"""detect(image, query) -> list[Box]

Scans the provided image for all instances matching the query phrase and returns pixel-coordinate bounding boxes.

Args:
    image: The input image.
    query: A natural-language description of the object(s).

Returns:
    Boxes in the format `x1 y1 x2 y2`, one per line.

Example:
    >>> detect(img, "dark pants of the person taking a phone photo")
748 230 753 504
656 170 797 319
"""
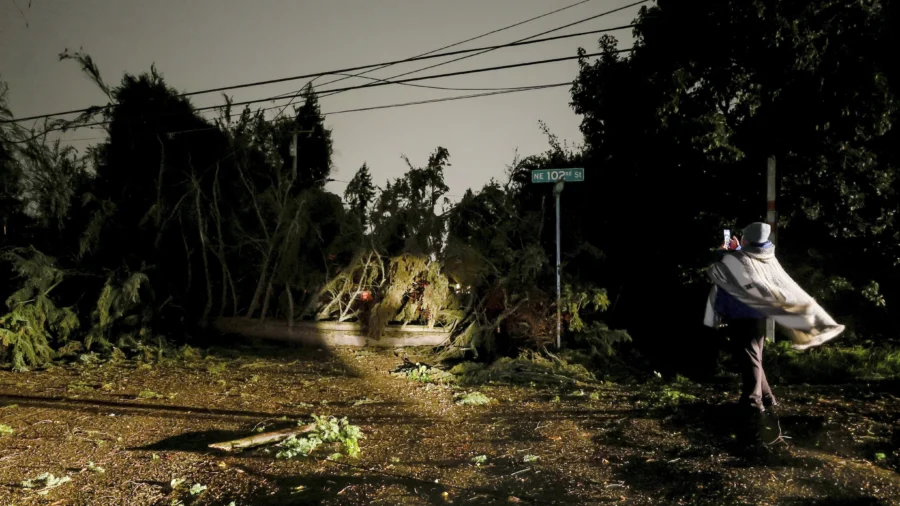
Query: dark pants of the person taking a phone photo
728 319 775 411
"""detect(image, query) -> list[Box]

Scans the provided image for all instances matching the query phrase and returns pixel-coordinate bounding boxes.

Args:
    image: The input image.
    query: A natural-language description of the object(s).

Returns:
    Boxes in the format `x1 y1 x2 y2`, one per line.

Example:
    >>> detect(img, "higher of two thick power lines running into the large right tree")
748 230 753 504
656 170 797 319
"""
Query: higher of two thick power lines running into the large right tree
0 23 632 123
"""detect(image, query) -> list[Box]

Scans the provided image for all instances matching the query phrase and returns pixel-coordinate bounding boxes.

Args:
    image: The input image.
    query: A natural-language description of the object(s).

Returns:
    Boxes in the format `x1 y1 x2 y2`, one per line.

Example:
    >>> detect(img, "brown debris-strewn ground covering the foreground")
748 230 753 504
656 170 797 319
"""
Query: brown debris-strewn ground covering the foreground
0 347 900 506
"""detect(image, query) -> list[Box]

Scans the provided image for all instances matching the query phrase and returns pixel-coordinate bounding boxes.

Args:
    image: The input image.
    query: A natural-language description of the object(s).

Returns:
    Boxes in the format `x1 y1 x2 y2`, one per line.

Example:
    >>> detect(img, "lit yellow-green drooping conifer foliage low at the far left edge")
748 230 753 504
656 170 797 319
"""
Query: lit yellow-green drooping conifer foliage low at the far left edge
0 248 79 370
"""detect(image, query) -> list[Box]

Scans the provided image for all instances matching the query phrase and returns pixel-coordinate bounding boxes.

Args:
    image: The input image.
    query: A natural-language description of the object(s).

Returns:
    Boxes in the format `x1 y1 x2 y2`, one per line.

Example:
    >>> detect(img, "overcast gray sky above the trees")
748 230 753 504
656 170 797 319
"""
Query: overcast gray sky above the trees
0 0 638 195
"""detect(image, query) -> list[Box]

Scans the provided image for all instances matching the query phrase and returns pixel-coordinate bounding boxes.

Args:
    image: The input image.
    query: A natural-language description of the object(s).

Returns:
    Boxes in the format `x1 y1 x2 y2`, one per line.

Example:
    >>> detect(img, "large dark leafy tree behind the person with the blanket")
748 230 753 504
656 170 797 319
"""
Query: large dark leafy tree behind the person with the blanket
568 0 900 356
